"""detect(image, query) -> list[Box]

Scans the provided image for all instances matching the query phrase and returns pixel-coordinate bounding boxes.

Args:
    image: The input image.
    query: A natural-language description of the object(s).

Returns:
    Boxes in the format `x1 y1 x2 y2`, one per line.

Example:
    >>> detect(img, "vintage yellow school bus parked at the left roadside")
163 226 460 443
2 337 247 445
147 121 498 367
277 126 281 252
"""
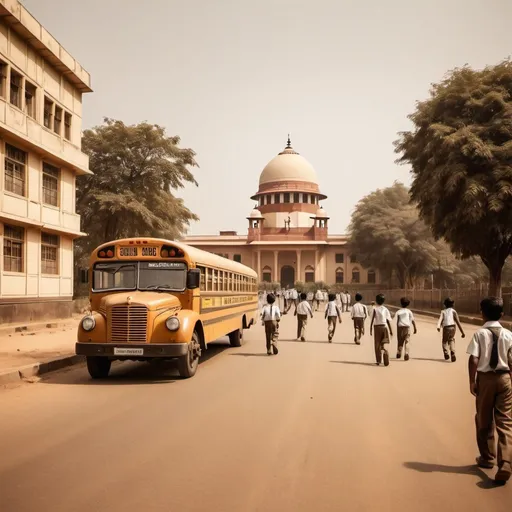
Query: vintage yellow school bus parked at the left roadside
76 238 258 379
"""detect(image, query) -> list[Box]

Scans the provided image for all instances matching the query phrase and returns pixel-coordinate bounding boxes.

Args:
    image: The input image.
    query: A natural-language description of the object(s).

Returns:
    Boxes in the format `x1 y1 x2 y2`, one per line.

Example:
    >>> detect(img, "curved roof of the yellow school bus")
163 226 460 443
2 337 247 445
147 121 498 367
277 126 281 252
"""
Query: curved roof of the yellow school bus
92 236 258 278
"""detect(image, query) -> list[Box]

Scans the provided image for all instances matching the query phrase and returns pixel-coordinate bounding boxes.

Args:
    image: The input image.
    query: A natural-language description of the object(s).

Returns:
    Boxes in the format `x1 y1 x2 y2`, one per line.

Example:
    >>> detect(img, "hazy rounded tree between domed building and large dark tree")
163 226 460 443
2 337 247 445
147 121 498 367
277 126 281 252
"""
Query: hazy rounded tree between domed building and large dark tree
349 183 449 288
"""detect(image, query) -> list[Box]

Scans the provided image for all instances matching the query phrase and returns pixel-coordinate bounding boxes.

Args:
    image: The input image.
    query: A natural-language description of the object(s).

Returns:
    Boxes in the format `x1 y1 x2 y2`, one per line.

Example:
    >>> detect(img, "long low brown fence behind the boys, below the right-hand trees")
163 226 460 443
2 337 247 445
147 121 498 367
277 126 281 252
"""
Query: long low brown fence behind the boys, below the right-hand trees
362 288 512 316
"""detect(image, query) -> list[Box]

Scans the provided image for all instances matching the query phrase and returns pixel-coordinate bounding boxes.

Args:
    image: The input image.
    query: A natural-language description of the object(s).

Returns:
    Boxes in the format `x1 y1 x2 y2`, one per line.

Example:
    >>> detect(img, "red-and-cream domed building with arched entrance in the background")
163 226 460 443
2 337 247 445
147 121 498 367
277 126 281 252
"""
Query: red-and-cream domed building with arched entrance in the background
184 138 379 288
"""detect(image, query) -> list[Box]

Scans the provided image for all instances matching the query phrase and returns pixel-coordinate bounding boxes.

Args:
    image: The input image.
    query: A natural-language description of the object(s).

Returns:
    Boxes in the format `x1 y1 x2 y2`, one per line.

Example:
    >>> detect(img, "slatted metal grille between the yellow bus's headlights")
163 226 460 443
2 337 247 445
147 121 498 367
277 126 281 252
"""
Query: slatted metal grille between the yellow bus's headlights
108 306 148 343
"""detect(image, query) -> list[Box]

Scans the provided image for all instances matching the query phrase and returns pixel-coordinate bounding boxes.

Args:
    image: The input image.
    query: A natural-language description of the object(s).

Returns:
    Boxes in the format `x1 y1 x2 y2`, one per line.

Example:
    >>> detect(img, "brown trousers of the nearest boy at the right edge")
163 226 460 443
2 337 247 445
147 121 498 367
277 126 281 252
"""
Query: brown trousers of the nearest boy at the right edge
475 372 512 468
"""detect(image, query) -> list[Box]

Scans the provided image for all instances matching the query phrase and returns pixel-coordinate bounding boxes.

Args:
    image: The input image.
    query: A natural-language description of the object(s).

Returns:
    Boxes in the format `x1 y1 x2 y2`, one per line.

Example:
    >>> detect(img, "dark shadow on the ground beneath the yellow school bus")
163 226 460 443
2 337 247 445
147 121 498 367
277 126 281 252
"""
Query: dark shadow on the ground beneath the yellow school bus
40 341 230 386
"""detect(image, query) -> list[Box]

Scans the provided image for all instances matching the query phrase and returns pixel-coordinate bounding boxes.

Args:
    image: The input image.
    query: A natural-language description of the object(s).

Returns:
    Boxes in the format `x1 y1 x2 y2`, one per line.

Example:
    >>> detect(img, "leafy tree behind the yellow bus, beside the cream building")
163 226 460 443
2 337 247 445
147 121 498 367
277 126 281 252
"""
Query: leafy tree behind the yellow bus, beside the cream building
77 118 197 262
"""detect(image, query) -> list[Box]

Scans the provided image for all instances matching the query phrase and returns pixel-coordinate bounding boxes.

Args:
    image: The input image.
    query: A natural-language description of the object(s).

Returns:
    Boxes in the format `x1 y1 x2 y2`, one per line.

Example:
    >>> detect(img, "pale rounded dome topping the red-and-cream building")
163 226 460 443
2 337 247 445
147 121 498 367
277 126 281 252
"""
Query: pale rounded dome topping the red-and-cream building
260 144 318 186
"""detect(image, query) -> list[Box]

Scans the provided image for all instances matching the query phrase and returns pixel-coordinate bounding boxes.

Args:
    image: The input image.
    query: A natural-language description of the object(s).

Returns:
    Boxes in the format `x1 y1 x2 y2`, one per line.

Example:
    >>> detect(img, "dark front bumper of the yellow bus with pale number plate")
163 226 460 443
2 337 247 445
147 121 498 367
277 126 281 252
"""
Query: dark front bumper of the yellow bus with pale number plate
75 342 188 359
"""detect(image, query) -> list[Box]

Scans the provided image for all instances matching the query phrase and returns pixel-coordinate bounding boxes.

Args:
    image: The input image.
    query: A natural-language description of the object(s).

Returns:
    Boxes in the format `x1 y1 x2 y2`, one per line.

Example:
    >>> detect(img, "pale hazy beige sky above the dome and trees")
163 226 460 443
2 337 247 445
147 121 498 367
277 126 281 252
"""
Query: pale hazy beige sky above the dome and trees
23 0 512 234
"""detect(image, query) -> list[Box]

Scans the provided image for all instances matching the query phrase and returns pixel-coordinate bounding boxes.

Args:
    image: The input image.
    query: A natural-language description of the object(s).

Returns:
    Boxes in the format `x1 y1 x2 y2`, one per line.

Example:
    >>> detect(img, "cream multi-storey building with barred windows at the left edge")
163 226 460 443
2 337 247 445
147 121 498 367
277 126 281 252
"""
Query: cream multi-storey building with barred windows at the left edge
0 0 91 322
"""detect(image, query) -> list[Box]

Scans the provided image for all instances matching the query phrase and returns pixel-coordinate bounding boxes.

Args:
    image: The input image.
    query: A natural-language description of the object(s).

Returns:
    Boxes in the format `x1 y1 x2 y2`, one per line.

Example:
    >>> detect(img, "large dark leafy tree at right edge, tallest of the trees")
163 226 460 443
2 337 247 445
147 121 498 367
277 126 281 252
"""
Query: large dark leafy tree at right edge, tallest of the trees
395 60 512 295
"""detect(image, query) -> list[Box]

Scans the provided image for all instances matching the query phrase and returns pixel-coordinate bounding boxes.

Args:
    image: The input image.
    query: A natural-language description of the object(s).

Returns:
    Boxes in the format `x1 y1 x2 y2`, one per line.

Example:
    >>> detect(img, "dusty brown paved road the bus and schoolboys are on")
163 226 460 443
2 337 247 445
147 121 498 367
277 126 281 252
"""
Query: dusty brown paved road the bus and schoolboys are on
0 315 512 512
